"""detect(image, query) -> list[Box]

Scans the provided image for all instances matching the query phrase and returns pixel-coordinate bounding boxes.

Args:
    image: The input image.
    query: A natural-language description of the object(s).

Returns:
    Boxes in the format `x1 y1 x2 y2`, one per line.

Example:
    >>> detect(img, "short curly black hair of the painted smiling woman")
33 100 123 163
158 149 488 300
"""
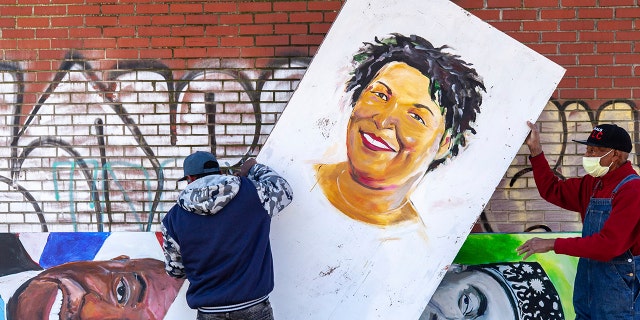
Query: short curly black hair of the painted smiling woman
346 33 486 170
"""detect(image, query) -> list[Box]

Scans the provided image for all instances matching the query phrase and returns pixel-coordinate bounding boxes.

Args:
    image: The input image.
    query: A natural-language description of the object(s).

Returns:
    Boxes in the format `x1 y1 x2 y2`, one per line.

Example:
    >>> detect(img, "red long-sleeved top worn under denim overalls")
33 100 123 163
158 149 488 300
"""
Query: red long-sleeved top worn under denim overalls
530 154 640 261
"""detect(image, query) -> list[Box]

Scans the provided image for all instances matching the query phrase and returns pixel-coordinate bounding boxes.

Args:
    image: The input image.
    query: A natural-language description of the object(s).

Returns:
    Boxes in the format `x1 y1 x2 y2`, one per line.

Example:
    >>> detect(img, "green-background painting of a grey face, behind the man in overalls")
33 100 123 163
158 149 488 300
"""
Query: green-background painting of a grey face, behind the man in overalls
420 233 580 320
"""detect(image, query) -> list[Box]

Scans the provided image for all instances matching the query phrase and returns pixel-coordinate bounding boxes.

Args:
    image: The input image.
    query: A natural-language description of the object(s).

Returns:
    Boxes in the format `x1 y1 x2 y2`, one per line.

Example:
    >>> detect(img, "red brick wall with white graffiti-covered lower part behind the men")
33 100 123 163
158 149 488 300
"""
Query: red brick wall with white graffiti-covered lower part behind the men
0 0 640 232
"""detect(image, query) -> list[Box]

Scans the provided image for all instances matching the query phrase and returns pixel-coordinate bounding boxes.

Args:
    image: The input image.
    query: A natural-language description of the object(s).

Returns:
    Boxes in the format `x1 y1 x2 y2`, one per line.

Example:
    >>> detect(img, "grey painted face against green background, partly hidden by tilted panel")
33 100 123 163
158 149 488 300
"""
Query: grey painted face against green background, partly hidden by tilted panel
421 271 518 320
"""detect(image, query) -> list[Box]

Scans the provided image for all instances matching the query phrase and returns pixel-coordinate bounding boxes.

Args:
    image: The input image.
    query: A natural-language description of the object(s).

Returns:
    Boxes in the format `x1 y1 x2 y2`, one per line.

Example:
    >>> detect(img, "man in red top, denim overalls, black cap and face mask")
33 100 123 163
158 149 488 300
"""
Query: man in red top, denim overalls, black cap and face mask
517 122 640 320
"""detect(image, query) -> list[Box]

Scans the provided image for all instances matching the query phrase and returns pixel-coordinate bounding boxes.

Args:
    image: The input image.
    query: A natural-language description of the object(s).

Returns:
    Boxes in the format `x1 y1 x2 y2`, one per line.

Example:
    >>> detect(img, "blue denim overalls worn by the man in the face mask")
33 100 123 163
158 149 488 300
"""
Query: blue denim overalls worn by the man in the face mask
573 174 640 320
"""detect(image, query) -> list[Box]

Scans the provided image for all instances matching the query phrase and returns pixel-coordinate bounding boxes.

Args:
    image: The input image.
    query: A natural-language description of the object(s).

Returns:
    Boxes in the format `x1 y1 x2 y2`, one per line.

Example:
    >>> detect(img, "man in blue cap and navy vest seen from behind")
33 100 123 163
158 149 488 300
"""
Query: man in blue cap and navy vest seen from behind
162 151 293 320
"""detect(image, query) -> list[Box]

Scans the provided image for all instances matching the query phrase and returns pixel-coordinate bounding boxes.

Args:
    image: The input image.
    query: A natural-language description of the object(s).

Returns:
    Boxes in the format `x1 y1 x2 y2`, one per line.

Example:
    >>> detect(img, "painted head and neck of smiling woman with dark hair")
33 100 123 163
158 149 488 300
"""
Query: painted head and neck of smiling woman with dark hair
316 34 486 226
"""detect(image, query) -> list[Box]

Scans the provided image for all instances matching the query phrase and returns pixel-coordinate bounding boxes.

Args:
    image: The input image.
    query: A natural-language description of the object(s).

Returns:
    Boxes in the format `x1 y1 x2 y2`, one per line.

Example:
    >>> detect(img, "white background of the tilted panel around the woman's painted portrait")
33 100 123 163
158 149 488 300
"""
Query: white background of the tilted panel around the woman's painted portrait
258 0 564 319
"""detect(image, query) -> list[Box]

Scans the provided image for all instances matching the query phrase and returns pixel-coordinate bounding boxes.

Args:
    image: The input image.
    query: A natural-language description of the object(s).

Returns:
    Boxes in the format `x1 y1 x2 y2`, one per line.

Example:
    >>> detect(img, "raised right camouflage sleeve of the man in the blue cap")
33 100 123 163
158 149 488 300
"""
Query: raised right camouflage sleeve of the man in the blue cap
247 163 293 216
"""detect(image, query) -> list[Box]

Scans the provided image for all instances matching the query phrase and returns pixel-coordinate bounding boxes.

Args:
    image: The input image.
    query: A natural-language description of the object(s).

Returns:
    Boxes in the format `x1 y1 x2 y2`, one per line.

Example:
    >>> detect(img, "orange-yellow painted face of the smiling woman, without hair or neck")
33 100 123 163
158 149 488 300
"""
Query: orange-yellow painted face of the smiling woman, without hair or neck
347 62 445 189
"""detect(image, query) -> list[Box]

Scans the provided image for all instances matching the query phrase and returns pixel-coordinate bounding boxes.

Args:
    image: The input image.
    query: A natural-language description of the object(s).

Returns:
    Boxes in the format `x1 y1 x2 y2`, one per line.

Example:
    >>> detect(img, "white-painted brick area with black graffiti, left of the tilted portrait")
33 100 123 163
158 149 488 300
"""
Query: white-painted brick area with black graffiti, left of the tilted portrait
0 51 308 231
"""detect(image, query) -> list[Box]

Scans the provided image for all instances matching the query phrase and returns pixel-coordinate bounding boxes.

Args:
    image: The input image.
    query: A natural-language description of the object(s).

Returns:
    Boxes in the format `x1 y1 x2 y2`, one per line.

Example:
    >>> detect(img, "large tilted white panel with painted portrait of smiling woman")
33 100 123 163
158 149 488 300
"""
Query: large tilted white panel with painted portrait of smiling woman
258 0 564 319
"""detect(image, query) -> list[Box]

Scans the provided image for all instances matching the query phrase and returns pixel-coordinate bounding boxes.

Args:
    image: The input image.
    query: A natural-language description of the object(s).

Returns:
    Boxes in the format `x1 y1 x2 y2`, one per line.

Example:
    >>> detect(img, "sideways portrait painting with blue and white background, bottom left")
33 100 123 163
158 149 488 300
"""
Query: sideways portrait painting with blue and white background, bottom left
0 233 195 320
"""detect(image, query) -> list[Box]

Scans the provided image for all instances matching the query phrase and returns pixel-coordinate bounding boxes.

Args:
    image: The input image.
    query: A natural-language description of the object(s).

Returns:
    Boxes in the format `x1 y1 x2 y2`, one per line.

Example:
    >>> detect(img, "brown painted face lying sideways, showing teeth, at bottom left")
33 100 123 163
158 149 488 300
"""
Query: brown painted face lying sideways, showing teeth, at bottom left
9 256 183 320
